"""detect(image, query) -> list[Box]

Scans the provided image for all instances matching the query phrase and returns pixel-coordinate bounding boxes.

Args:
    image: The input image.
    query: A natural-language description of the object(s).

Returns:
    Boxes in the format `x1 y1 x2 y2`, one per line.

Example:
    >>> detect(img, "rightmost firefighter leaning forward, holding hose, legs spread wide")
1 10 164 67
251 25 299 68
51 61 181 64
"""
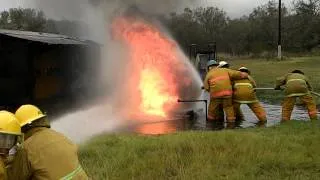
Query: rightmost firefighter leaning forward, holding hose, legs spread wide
275 70 318 121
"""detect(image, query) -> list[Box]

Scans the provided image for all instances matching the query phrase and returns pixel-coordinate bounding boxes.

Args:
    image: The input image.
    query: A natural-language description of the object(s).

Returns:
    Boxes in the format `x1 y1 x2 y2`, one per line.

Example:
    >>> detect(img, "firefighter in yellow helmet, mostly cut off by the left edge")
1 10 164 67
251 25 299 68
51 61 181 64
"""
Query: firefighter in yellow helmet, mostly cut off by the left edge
0 111 21 180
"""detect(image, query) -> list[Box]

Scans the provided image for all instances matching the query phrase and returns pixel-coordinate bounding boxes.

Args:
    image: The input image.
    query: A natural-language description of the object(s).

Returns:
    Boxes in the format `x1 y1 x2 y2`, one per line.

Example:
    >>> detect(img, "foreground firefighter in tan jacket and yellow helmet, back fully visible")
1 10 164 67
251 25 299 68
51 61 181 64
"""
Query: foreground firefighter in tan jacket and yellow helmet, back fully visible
8 105 88 180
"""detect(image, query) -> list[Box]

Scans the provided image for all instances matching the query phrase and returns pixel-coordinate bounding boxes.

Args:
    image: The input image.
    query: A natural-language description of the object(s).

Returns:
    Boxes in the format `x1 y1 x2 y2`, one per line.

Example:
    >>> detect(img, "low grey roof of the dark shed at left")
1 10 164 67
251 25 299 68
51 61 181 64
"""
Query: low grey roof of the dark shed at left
0 29 90 45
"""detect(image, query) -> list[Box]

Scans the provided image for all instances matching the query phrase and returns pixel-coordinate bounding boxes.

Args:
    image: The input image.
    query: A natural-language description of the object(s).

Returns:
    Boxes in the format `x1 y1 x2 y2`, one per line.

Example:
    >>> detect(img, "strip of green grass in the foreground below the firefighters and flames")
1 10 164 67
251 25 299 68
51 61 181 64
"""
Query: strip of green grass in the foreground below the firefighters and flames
80 121 320 180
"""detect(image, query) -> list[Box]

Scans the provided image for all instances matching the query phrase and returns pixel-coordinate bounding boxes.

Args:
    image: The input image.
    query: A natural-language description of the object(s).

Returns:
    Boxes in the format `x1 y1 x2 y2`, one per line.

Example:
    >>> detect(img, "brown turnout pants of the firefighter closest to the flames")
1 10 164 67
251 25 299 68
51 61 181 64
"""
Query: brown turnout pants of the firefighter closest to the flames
208 97 236 122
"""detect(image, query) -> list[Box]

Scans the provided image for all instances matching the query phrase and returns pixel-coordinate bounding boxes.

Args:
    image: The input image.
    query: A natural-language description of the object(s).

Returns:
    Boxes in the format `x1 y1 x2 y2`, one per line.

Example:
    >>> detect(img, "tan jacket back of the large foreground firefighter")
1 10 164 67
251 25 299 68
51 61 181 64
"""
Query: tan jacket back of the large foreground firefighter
24 128 88 180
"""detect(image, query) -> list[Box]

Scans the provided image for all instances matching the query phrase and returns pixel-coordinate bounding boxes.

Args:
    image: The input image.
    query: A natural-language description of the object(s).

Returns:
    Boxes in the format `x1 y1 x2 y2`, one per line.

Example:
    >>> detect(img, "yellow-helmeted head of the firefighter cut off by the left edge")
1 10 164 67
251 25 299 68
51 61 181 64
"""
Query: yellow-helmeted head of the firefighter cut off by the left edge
0 111 22 154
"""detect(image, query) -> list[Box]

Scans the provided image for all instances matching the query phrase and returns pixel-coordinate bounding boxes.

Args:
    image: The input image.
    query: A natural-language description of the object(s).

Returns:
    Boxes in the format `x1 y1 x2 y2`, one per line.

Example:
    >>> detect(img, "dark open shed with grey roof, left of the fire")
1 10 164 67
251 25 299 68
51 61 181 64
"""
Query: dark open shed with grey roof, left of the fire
0 29 100 114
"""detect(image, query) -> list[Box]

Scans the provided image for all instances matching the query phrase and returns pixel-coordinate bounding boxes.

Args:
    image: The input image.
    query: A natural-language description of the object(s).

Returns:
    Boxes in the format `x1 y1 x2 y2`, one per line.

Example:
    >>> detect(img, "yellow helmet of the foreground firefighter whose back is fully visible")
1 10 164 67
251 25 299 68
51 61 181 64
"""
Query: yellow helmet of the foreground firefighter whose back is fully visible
15 104 46 127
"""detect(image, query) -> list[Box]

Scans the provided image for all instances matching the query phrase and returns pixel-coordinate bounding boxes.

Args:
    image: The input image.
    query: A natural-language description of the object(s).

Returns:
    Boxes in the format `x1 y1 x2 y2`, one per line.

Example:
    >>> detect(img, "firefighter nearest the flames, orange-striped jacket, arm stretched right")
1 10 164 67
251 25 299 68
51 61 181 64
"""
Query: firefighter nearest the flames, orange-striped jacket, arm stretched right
204 60 248 123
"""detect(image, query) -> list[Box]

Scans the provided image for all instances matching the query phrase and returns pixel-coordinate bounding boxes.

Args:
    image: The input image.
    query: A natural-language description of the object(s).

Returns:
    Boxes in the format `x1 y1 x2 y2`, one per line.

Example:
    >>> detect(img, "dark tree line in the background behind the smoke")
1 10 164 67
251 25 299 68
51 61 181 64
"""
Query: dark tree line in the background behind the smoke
0 0 320 56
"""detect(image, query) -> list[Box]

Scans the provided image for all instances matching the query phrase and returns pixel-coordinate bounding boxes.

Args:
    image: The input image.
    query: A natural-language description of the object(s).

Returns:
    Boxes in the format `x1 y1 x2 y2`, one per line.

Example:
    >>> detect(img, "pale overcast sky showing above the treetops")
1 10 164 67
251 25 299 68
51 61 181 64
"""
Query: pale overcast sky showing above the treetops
0 0 293 19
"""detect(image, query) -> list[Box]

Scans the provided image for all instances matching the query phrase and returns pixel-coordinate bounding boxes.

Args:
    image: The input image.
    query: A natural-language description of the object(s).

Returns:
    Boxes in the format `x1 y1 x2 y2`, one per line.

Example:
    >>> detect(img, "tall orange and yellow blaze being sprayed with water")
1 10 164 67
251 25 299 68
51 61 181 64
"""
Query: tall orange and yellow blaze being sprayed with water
112 17 198 119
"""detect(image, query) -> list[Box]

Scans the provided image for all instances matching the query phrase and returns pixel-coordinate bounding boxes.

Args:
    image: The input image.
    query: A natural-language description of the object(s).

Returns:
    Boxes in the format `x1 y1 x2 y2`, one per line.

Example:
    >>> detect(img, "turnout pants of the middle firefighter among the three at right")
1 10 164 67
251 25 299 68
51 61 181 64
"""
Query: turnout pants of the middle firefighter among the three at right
233 102 267 122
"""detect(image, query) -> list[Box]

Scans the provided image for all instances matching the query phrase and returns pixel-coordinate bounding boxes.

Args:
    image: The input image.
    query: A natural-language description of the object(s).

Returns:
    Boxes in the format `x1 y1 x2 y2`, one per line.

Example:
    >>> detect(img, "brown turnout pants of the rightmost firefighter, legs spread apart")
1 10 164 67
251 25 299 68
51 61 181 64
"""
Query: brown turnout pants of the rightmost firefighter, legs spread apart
282 95 318 121
